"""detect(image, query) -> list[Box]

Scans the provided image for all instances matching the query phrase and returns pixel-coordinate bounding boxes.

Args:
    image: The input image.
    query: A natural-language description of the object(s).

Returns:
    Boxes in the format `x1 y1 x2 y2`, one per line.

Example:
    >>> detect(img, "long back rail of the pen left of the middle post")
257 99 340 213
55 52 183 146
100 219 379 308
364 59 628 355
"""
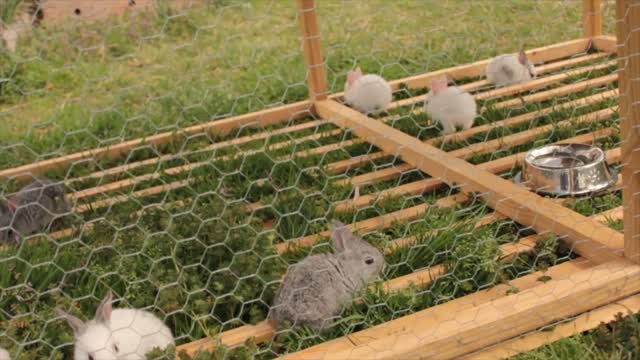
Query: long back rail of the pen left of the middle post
0 101 312 179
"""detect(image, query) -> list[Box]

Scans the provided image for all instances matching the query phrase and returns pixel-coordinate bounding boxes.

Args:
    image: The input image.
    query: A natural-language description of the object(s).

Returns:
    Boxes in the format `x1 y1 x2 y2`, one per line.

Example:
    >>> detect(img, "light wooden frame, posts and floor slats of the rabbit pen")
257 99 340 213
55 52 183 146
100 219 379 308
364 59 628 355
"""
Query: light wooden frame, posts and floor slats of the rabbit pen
0 0 640 359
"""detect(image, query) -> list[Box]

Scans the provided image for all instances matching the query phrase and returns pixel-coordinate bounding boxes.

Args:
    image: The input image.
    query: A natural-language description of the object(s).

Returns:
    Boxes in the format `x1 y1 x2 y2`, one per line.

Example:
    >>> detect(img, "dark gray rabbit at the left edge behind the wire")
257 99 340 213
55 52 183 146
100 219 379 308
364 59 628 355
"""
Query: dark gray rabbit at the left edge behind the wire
0 178 71 244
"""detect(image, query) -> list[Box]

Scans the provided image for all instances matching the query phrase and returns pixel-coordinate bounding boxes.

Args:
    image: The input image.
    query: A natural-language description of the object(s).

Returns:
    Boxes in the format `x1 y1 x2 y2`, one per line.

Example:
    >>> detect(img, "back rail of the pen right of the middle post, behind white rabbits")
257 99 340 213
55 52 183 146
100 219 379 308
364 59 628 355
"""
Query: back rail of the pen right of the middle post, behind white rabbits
382 39 590 90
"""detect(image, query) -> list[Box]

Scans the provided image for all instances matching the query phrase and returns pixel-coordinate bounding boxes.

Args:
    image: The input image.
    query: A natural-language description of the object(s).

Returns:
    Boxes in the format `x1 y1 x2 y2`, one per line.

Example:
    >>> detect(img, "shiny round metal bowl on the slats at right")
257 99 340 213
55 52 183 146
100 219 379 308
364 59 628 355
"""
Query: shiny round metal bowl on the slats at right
516 144 617 196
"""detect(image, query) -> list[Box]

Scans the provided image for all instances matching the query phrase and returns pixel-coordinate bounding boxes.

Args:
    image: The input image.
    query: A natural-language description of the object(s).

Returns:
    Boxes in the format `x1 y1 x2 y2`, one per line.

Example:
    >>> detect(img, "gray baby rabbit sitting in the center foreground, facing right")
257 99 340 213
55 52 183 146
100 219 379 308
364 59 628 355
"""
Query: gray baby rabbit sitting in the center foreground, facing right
269 221 384 331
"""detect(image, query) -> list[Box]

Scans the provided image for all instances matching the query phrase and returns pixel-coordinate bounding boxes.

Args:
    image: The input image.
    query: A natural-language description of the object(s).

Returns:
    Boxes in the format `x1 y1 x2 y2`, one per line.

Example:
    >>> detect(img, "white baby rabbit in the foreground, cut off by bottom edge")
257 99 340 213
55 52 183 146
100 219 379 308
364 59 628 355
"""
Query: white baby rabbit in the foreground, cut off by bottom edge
55 291 175 360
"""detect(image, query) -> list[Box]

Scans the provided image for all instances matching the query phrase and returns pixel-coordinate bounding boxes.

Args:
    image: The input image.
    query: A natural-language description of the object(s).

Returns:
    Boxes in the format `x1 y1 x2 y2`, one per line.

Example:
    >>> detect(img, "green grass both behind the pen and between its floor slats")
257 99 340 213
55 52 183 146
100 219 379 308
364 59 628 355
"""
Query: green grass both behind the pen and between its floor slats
0 0 637 359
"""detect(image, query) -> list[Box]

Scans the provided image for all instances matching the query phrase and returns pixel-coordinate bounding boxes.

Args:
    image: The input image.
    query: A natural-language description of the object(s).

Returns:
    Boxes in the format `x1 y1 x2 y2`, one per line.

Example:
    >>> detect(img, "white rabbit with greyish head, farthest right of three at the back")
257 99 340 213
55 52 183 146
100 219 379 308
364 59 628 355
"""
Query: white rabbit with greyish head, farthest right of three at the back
486 50 536 86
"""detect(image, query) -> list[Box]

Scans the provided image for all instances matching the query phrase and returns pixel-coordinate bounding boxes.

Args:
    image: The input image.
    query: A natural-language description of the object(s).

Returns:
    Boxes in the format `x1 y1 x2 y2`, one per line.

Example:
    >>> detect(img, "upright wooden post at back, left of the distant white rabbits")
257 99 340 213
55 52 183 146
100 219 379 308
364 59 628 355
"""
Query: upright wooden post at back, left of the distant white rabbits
297 0 328 101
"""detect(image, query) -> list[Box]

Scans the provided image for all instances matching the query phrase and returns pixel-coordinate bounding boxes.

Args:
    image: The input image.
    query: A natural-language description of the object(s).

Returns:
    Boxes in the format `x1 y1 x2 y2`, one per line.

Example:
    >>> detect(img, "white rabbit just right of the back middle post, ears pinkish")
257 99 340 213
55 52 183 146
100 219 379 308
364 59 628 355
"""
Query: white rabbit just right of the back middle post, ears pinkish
344 68 391 115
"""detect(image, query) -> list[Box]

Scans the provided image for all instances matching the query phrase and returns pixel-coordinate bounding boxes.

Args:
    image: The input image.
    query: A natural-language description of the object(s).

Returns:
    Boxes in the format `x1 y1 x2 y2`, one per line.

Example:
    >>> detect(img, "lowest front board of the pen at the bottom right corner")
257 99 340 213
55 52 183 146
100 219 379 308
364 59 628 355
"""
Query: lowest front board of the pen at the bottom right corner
460 295 640 360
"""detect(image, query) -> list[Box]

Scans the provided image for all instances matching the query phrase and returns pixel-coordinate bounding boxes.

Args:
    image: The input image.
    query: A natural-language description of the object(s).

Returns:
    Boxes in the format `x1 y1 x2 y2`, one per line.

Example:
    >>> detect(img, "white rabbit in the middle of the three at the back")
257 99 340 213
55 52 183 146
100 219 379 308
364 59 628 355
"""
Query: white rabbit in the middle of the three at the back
425 77 477 135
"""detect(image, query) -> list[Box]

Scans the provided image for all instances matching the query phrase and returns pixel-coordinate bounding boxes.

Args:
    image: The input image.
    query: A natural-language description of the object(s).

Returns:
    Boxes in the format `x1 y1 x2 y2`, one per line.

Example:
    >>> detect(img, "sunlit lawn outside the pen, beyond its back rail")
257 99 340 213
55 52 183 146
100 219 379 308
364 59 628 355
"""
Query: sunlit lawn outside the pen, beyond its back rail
0 0 596 167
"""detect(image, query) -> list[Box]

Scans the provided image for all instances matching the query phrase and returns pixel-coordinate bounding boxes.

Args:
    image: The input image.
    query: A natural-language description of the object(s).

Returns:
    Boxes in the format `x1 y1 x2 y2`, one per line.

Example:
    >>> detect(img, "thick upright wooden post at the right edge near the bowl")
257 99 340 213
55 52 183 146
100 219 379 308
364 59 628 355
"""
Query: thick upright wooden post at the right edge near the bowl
616 0 640 263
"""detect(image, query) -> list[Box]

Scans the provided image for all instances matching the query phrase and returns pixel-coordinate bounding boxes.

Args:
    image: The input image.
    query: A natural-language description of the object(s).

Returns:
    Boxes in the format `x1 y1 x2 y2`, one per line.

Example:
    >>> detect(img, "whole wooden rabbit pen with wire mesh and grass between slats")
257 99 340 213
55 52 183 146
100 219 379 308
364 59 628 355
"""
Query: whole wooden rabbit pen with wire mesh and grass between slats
0 0 640 359
